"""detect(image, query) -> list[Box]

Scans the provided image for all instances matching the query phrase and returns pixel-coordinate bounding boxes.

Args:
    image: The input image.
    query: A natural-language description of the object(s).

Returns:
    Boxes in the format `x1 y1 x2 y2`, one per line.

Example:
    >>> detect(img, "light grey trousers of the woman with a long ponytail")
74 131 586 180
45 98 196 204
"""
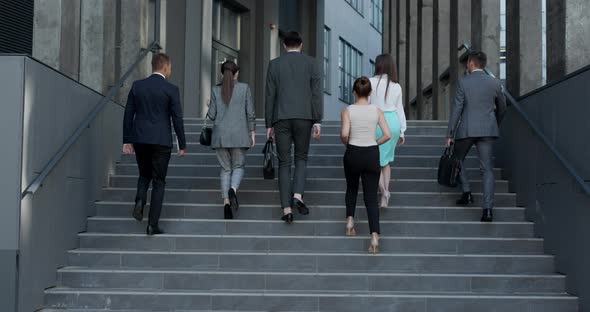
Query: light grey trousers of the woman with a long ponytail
215 148 247 199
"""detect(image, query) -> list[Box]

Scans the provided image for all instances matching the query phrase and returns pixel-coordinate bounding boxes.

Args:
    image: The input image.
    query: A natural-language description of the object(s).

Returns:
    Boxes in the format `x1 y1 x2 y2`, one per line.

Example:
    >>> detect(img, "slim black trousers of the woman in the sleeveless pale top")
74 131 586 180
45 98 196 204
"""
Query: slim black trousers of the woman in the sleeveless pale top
344 145 381 233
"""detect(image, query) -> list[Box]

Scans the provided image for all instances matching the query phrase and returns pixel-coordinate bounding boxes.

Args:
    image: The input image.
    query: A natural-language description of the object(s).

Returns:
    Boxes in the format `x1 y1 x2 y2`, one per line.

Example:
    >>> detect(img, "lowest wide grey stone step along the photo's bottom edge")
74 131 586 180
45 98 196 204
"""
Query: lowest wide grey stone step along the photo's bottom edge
46 288 578 312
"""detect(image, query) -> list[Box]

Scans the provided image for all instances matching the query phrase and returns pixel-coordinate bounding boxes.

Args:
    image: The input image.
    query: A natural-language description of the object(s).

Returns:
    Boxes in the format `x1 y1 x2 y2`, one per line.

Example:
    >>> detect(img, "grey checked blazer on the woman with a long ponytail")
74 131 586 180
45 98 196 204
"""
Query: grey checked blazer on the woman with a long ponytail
207 82 256 149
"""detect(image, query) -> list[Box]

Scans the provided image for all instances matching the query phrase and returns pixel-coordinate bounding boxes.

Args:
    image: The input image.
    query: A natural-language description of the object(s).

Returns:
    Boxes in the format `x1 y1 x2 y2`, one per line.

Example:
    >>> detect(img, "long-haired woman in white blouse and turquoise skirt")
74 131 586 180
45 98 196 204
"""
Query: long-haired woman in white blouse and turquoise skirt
369 54 406 208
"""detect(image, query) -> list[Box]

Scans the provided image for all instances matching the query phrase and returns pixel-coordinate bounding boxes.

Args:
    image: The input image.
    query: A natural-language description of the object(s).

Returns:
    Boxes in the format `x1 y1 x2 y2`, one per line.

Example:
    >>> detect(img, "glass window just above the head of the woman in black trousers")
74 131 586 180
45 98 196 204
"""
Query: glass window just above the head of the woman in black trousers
338 38 363 104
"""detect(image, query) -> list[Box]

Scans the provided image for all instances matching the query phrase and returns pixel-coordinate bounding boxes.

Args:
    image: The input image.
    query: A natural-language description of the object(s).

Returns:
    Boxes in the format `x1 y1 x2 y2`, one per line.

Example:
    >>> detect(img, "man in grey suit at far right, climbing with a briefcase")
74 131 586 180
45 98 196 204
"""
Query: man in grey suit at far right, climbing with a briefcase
446 52 506 222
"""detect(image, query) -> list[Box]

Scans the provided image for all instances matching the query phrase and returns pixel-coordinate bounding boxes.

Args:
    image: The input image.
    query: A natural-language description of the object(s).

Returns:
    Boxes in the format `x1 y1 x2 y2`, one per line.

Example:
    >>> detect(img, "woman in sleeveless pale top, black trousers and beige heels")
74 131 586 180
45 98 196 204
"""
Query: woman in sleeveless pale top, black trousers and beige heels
340 77 391 254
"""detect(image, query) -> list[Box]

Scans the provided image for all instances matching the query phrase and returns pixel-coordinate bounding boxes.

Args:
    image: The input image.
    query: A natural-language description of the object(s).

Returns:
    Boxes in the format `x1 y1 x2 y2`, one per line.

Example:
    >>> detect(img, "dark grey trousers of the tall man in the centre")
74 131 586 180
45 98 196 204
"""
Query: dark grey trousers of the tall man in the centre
273 119 313 208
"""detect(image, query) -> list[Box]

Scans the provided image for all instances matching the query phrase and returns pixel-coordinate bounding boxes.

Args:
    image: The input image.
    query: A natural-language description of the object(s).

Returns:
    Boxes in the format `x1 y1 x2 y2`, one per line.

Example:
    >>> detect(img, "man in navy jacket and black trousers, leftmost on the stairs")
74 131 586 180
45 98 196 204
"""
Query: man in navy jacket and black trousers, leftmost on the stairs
123 53 186 235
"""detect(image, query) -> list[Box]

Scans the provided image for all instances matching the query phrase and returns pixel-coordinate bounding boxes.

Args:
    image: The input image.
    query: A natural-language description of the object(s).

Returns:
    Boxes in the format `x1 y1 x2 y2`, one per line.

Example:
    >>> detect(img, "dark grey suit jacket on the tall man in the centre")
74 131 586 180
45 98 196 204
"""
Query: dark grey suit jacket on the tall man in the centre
265 52 324 128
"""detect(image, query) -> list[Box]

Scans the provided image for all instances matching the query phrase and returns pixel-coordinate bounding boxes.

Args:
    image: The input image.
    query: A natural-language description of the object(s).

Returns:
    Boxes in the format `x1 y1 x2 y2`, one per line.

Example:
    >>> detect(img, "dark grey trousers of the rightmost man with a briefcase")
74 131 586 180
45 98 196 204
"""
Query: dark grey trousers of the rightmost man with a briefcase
455 137 496 209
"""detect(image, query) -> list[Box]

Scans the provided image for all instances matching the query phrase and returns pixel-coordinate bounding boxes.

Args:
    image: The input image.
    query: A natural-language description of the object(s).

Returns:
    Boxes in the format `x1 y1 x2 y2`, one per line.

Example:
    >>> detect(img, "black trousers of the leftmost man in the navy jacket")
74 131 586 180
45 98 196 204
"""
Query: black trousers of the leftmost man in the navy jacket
133 144 172 226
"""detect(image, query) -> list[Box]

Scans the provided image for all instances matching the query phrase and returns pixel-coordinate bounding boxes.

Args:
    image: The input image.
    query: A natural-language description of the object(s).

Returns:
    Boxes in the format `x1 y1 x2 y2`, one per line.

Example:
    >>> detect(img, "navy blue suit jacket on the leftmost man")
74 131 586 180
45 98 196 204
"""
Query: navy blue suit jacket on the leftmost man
123 74 186 149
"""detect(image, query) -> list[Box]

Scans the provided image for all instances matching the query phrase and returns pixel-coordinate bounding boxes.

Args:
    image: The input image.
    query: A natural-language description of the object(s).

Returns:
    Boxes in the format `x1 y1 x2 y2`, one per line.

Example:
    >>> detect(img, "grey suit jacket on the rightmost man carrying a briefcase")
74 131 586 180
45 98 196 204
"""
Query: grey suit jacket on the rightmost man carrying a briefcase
447 71 506 140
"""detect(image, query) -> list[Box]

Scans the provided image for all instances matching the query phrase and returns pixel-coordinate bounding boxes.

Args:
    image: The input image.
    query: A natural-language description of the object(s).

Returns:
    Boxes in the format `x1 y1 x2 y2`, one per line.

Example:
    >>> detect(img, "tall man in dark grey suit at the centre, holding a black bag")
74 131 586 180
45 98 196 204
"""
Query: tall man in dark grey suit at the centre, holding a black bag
265 31 324 223
